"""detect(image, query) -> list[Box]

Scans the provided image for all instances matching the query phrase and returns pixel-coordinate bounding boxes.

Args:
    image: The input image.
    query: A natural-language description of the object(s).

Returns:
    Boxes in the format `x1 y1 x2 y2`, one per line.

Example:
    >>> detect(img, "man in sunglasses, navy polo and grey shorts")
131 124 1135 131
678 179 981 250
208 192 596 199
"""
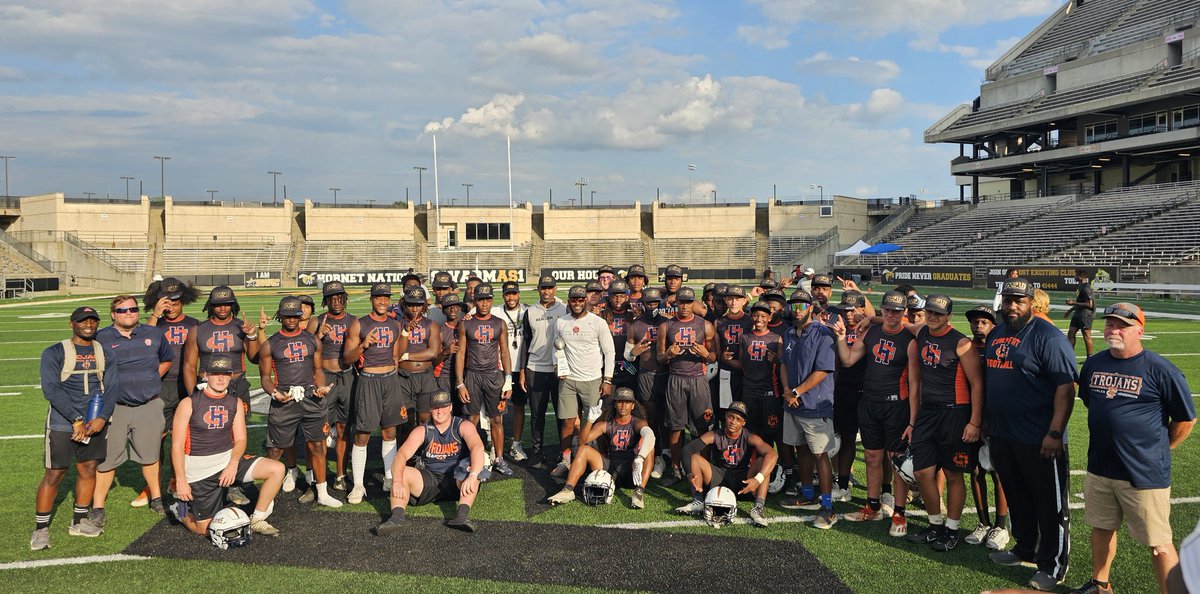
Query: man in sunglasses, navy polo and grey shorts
89 295 175 524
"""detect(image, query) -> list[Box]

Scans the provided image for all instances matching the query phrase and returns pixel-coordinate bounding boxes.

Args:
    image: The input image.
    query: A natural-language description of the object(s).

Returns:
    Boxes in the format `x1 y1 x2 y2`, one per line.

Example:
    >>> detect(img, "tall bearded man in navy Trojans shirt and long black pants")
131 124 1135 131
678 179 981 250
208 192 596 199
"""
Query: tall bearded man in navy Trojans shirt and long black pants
984 277 1076 590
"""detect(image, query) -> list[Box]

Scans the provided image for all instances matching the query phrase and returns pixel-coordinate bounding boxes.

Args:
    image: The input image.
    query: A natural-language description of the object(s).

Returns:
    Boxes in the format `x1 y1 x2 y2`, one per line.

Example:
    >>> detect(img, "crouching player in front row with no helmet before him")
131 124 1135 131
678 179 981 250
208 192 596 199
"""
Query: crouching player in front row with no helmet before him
376 391 486 536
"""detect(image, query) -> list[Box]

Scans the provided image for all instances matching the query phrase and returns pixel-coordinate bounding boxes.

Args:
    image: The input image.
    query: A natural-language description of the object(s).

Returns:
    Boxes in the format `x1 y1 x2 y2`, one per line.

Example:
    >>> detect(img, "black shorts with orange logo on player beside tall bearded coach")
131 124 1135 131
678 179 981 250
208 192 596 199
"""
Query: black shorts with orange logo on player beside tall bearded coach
910 406 979 473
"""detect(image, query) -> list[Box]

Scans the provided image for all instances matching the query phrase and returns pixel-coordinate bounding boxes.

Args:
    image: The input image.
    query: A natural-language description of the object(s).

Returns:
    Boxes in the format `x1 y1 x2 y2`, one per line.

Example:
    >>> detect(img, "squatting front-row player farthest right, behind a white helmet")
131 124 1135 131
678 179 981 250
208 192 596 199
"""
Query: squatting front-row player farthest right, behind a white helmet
676 402 779 528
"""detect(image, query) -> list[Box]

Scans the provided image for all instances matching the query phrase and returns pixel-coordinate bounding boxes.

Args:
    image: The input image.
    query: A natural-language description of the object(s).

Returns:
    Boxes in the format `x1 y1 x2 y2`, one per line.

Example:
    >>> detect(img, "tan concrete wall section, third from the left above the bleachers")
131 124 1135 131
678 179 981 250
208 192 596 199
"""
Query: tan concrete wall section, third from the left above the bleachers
304 200 415 241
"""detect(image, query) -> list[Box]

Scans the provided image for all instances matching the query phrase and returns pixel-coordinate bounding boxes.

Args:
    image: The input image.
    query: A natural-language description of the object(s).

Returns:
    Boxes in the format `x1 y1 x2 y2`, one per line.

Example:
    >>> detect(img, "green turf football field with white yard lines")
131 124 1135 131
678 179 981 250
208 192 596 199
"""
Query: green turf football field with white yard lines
0 285 1200 593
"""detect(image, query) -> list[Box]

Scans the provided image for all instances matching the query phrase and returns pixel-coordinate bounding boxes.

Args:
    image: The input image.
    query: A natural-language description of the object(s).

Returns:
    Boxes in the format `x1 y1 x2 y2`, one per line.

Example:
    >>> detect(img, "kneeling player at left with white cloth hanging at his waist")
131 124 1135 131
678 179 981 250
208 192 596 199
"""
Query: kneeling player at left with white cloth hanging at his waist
170 354 283 536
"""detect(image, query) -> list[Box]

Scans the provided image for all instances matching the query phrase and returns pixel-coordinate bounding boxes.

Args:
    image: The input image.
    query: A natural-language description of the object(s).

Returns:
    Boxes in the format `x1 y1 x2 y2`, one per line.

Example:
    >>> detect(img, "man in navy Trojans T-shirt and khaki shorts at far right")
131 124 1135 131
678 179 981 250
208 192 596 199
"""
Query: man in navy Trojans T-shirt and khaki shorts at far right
1073 304 1196 593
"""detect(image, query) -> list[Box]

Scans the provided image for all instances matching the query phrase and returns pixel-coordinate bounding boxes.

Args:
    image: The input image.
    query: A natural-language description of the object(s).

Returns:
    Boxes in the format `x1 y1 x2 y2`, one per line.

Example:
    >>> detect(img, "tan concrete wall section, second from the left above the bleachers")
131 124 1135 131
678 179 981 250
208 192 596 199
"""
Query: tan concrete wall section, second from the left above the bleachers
164 196 293 244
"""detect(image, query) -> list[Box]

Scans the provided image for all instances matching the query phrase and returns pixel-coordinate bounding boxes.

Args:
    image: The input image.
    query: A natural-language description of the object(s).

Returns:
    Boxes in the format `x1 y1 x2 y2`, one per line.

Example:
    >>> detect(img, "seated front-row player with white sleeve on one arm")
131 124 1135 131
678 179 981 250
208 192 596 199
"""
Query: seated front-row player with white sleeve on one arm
547 388 654 509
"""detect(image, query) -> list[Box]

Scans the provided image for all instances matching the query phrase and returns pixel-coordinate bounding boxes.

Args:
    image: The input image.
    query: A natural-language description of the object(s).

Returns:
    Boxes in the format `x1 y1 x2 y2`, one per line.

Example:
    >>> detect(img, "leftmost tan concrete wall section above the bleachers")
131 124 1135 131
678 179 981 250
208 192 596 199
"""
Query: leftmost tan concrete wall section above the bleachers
8 193 150 245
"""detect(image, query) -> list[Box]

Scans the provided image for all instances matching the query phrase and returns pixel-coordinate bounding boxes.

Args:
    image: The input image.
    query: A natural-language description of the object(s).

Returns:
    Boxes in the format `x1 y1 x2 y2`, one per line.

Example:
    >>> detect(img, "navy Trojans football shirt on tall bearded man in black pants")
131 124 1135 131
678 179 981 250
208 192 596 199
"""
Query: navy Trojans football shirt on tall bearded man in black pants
984 317 1076 445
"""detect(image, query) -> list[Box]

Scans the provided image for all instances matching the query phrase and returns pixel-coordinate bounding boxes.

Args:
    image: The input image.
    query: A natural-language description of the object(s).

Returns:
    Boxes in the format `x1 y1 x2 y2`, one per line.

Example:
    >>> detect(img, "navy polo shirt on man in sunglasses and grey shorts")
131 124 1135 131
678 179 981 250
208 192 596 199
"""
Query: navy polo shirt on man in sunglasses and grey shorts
96 324 175 406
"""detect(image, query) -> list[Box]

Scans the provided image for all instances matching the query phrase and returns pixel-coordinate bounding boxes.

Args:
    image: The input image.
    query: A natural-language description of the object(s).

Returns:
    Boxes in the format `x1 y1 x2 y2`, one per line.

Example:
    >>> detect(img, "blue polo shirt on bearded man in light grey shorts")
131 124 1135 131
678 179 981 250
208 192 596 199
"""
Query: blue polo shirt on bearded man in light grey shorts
784 323 838 418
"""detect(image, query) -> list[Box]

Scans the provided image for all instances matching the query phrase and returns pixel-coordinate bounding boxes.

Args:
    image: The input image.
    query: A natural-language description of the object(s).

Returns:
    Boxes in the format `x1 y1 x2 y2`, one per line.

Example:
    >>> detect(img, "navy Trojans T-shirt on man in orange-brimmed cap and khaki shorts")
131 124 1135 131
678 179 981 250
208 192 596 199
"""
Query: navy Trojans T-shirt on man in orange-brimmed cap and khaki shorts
1079 350 1196 488
